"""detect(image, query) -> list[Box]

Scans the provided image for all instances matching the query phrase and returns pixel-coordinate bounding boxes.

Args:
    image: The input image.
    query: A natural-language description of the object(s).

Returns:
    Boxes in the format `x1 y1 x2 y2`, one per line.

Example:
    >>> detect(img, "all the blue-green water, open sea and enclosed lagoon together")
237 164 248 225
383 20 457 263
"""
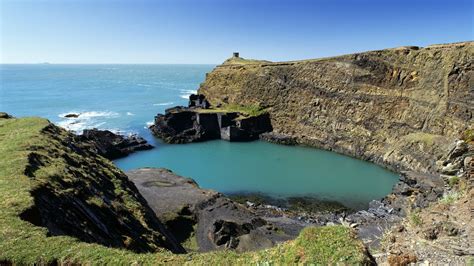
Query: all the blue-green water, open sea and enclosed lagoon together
0 64 398 209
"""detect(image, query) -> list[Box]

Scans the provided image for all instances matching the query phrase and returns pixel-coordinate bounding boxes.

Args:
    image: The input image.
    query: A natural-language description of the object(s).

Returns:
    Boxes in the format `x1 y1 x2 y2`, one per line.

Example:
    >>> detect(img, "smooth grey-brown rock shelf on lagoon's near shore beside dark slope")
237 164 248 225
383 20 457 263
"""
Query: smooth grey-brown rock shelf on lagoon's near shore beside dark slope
127 168 303 251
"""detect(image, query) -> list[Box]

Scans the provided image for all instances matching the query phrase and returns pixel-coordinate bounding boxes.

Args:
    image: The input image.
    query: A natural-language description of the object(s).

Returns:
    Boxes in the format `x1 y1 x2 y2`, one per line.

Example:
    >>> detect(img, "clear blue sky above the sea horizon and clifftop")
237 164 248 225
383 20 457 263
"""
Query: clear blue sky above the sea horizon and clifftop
0 0 474 64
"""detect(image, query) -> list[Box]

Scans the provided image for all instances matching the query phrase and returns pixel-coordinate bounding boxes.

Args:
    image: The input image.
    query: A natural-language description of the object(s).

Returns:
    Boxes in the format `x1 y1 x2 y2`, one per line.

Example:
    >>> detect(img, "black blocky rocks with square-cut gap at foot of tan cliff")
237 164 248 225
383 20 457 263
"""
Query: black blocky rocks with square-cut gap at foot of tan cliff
150 95 272 143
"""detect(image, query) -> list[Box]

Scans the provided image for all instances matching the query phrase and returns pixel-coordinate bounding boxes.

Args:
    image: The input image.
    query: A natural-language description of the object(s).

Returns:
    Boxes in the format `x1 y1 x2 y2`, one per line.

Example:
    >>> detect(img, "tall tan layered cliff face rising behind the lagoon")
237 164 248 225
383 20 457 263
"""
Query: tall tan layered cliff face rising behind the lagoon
199 42 474 172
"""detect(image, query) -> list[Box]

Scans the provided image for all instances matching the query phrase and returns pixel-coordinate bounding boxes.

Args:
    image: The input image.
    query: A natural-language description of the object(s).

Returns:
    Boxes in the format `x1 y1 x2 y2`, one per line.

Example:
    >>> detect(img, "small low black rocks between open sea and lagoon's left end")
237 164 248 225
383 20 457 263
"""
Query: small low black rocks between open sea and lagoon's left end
79 129 153 160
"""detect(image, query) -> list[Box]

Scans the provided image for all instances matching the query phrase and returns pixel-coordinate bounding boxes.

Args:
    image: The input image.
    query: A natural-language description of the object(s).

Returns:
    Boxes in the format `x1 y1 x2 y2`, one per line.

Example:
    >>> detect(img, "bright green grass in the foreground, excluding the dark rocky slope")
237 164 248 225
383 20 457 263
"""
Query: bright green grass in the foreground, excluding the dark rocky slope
0 118 366 264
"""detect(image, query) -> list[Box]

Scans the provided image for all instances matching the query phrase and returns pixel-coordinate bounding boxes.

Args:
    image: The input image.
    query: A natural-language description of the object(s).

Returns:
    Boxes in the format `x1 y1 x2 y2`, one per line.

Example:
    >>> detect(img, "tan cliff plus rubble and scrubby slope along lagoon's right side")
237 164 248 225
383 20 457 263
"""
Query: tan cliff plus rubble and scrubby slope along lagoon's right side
194 42 474 265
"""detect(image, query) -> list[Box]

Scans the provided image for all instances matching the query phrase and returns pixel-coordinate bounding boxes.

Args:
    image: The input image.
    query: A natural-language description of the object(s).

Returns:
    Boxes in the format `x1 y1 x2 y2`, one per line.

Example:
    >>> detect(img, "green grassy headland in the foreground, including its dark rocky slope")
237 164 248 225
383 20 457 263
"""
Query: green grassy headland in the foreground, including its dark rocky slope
0 116 368 264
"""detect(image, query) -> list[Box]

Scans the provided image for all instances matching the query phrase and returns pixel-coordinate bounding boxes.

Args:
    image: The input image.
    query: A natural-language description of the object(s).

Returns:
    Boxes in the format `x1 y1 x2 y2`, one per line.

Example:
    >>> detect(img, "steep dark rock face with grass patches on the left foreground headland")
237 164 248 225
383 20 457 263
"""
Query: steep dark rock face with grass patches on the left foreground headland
17 119 184 253
